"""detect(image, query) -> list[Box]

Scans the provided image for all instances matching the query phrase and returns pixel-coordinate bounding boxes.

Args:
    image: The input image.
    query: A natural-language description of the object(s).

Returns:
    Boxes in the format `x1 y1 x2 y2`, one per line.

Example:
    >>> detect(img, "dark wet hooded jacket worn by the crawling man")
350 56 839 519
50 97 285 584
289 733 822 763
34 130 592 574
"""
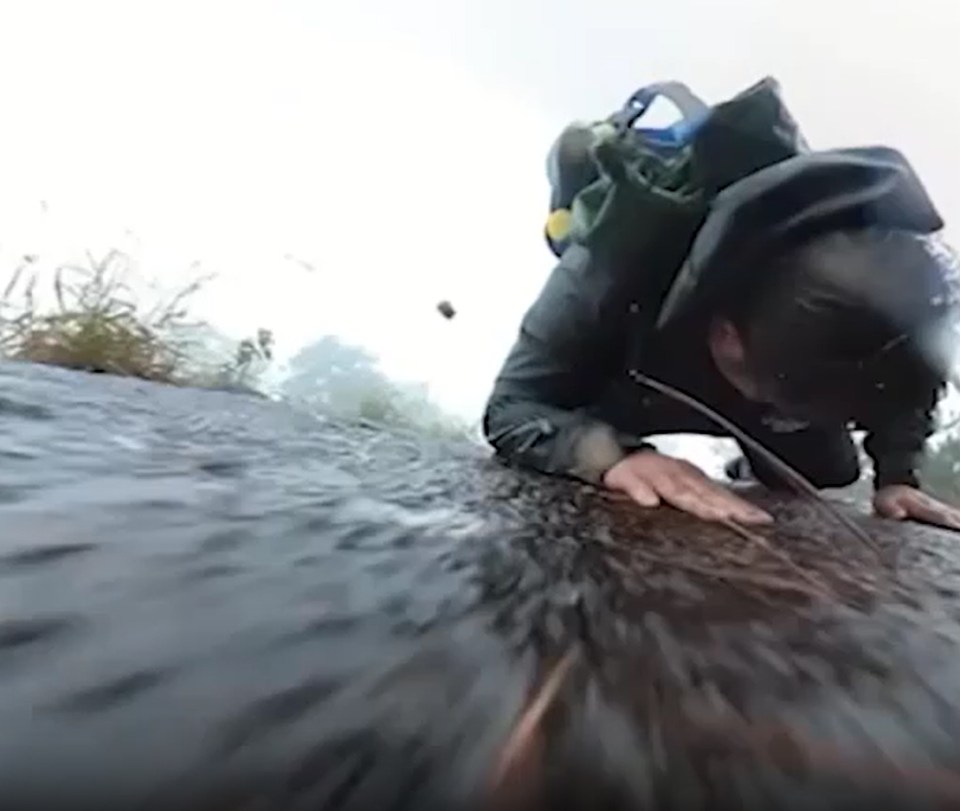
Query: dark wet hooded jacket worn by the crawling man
483 149 943 487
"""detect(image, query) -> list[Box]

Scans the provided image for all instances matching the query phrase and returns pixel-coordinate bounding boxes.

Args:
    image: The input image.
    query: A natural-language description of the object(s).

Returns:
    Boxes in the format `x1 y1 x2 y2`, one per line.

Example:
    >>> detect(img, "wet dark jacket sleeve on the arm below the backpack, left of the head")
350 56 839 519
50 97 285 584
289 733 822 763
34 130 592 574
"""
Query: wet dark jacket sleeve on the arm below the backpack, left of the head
483 246 649 483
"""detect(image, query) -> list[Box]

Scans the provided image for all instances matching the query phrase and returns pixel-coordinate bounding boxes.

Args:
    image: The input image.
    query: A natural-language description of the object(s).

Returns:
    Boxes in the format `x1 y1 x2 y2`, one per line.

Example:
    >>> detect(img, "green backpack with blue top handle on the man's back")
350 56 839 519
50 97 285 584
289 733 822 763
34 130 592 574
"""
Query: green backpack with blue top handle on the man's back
545 77 807 320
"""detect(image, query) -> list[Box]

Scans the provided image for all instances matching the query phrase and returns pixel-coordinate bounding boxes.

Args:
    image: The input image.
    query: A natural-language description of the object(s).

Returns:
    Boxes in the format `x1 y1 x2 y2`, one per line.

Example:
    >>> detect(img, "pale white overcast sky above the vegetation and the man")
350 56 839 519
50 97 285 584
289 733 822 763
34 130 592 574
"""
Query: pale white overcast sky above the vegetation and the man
0 0 960 432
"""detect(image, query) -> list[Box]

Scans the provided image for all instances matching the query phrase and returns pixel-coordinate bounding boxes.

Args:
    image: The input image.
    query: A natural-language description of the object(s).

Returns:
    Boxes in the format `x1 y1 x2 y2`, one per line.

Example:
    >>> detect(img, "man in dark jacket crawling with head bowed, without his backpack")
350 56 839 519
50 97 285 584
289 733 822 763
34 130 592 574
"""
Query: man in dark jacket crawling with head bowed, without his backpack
484 131 960 528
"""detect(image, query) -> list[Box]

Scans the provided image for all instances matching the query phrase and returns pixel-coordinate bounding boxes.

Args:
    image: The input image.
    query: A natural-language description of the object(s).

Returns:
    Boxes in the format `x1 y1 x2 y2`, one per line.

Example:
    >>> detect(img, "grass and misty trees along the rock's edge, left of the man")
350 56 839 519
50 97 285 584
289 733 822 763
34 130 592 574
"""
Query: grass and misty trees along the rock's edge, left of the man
0 250 477 439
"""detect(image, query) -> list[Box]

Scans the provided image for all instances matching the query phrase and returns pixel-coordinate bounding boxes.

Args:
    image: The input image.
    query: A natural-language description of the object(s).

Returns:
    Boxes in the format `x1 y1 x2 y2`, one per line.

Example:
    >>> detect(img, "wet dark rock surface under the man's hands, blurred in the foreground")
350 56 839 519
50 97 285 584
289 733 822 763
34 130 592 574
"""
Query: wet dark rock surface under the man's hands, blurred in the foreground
0 364 960 811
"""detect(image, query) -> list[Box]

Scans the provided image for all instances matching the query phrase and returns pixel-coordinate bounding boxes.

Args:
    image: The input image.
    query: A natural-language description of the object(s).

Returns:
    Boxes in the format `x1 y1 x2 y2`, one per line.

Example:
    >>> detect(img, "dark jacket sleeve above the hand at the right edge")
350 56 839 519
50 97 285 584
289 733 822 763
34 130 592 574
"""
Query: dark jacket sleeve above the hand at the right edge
863 389 940 490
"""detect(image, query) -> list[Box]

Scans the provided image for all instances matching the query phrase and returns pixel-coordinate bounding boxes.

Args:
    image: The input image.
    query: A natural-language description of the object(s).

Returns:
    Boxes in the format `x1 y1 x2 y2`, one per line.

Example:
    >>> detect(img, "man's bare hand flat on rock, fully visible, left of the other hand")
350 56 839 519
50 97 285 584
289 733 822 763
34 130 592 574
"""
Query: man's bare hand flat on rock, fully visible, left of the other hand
603 450 773 524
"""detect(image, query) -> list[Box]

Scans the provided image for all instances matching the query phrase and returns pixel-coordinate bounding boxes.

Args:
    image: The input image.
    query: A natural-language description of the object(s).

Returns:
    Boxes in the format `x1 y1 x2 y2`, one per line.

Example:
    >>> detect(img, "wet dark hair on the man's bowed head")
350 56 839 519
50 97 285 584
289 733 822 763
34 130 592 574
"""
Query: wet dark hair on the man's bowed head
729 228 958 422
